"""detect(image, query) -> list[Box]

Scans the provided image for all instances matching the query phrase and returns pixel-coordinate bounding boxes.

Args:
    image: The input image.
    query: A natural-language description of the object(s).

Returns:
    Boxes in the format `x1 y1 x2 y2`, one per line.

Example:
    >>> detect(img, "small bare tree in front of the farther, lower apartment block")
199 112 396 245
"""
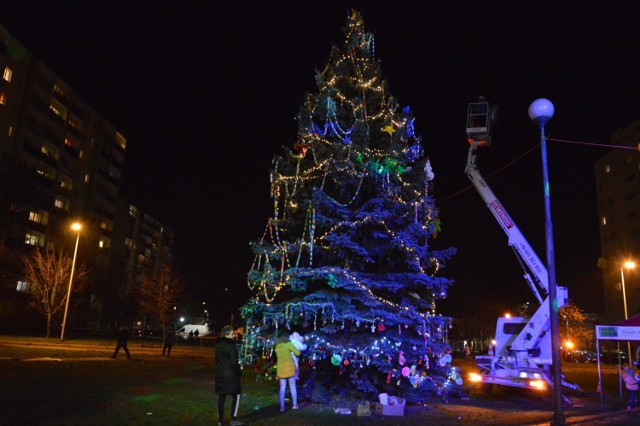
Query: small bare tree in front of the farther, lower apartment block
134 268 187 343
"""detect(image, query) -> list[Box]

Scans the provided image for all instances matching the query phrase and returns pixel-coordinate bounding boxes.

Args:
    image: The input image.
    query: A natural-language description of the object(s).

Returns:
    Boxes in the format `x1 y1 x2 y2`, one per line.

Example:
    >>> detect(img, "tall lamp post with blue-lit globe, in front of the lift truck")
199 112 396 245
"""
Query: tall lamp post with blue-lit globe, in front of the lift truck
529 98 565 425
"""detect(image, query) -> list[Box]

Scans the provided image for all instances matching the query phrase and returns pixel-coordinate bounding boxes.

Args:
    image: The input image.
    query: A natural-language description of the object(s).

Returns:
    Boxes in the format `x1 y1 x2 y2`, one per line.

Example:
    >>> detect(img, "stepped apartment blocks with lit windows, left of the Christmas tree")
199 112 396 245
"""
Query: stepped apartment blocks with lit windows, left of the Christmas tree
0 26 174 329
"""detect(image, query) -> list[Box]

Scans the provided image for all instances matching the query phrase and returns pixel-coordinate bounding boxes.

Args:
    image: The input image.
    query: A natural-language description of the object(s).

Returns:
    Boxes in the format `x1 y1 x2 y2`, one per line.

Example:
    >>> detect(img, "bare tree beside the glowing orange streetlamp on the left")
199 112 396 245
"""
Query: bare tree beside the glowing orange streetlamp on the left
22 248 87 338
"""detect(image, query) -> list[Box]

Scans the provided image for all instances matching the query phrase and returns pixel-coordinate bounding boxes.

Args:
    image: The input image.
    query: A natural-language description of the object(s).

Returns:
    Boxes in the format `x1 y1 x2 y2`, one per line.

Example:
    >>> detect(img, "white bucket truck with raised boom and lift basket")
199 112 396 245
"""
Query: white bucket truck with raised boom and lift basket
465 98 580 402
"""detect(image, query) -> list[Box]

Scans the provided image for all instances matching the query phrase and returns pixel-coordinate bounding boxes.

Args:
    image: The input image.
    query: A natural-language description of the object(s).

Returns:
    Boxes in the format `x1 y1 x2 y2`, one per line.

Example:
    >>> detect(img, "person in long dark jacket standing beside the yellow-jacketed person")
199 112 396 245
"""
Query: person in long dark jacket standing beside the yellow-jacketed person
216 325 243 426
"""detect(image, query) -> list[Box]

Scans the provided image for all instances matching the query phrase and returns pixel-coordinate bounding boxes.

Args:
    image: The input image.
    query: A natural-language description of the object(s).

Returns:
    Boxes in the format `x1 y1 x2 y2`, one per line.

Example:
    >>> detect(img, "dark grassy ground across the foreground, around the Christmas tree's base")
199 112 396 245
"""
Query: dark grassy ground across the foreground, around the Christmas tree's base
0 336 640 426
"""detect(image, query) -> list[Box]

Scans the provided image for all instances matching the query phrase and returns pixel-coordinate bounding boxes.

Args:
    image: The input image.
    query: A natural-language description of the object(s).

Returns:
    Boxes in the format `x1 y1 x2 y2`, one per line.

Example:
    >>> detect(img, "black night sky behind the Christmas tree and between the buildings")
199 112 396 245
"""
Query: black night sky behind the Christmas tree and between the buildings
0 0 640 322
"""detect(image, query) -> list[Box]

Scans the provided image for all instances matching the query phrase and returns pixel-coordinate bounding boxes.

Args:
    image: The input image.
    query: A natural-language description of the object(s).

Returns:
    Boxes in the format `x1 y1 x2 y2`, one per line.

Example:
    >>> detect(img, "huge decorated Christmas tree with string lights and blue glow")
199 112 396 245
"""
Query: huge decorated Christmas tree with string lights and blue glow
242 11 461 401
